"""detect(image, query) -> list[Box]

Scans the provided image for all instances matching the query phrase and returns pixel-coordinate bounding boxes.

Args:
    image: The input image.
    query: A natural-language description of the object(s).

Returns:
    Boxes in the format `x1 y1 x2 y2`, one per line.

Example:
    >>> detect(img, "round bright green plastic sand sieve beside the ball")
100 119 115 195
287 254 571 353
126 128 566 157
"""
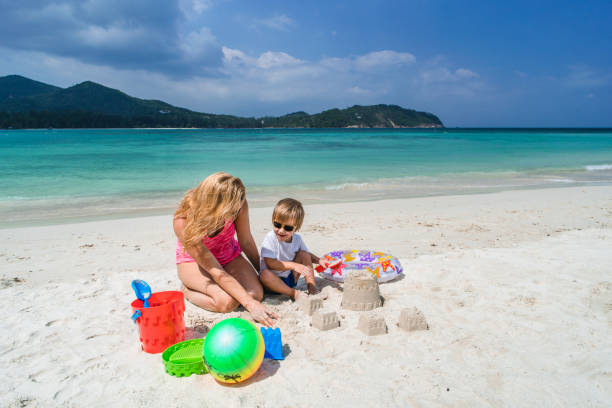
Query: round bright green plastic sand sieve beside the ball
162 339 207 377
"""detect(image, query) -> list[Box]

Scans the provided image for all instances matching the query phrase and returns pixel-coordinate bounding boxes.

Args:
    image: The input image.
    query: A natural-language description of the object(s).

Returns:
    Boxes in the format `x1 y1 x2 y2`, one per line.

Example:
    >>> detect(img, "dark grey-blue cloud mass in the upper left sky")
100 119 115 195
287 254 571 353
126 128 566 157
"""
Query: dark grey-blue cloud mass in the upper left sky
0 0 223 77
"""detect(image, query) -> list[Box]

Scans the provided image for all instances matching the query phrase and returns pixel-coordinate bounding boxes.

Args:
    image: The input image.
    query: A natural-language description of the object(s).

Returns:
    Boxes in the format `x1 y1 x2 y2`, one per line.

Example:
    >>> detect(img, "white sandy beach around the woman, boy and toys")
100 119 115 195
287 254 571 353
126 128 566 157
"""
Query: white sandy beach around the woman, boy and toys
0 187 612 407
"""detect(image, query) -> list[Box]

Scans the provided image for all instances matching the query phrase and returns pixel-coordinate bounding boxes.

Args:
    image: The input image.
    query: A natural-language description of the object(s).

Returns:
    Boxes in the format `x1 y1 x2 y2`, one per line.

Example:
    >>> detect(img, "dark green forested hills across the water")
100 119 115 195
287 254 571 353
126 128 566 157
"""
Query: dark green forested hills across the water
0 75 443 129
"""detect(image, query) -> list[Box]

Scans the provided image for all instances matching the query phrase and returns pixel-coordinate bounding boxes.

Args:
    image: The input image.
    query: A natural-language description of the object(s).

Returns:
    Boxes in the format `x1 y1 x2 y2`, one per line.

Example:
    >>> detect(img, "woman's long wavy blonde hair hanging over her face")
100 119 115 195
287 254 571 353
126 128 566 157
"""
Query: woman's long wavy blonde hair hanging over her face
174 171 246 246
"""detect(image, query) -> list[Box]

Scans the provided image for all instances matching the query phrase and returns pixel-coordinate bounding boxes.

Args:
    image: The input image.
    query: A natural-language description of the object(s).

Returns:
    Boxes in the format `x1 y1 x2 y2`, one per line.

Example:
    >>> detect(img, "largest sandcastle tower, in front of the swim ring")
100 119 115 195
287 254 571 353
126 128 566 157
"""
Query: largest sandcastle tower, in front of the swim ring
342 271 382 310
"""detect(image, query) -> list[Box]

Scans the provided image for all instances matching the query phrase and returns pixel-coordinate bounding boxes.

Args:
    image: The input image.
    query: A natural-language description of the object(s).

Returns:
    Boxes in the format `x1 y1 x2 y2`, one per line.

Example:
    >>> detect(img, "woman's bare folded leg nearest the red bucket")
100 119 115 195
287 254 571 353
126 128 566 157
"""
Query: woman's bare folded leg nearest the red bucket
177 262 238 313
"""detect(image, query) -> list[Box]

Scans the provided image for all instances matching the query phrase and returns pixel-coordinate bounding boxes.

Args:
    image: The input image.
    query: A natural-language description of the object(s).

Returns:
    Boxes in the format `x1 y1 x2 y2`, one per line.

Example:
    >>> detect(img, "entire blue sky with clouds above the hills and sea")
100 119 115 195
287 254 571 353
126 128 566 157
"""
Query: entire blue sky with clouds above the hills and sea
0 0 612 127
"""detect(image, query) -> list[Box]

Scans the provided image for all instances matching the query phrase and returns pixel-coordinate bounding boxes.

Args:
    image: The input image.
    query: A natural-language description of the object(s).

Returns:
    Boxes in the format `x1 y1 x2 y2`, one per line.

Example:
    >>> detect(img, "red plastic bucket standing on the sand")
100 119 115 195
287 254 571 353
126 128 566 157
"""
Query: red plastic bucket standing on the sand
132 291 185 353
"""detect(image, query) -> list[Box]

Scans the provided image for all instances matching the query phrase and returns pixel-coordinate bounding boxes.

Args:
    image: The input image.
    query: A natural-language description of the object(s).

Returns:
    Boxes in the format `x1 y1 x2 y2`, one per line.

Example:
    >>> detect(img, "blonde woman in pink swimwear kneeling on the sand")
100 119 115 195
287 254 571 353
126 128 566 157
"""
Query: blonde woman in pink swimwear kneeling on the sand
174 172 277 326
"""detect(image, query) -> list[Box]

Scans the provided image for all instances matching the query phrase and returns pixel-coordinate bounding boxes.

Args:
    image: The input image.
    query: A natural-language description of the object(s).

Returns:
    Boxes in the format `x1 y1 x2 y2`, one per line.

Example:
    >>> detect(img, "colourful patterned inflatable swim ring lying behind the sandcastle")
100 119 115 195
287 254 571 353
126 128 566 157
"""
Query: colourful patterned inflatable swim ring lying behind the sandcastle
315 249 404 283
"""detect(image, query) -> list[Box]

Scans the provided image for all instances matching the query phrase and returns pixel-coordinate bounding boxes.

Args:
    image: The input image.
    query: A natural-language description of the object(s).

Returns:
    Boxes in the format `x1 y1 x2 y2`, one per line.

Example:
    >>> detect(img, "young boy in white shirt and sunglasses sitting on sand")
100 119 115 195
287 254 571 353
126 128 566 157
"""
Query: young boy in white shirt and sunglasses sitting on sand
259 198 328 300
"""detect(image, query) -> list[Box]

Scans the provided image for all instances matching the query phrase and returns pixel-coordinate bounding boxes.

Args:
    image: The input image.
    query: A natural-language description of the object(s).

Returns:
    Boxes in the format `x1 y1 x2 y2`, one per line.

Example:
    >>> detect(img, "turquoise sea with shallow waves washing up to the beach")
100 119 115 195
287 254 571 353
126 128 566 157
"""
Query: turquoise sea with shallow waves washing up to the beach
0 129 612 227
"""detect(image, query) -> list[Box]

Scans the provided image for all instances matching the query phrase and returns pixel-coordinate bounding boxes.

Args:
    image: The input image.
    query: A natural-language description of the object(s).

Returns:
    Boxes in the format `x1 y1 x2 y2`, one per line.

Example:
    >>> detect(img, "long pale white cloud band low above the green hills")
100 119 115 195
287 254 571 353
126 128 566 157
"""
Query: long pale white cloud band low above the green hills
0 42 482 116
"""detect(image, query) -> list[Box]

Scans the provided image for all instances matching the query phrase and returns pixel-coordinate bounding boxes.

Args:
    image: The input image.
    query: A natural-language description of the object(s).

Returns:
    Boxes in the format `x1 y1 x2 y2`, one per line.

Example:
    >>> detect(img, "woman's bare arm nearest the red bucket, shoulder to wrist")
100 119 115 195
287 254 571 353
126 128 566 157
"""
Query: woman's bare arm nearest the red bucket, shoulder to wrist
173 218 259 310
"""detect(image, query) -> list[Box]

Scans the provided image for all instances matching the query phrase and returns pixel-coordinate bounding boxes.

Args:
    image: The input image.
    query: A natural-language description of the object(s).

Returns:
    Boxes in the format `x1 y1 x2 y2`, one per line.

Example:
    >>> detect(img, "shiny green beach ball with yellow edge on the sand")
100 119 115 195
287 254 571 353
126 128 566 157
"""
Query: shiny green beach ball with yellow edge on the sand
203 318 265 383
